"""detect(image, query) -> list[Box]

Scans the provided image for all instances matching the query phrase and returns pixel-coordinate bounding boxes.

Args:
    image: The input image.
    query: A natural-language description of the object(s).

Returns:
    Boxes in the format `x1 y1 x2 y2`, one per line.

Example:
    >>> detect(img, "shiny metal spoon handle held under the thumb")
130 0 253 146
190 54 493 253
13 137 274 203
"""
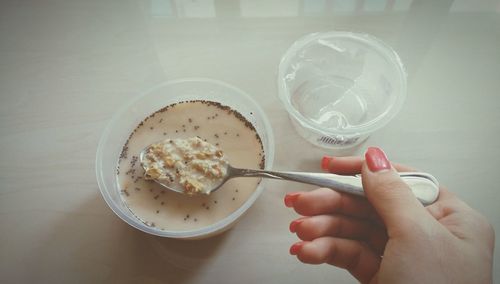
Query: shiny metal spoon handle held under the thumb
232 168 439 205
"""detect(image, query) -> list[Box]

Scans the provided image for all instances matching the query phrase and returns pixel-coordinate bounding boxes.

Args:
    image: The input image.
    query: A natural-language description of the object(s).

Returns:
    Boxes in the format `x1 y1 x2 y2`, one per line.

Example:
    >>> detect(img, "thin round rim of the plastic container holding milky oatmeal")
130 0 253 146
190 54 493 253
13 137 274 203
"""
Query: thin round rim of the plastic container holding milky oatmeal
95 77 275 239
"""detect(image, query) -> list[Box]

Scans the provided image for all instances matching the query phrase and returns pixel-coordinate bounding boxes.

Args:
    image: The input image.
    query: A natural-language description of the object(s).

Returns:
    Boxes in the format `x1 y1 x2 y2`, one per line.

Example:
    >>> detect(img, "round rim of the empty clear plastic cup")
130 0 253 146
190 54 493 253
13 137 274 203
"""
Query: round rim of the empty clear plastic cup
278 31 407 135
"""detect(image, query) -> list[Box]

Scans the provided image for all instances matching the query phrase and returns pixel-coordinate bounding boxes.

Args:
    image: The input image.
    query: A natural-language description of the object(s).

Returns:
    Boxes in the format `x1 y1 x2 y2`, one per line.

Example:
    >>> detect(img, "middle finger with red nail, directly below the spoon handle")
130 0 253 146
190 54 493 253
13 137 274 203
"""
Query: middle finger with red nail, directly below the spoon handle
285 188 376 219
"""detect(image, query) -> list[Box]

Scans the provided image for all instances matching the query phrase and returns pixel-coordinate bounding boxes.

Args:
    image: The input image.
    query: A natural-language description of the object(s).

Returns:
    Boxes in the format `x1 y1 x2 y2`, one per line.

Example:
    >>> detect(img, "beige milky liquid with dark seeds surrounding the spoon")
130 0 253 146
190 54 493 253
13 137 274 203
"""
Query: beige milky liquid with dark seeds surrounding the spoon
117 101 264 230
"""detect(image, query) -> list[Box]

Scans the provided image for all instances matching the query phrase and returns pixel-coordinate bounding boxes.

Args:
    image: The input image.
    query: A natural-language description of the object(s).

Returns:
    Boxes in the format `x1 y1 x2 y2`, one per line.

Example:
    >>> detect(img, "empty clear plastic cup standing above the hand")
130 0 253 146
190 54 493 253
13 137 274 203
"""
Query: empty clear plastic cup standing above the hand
278 32 406 149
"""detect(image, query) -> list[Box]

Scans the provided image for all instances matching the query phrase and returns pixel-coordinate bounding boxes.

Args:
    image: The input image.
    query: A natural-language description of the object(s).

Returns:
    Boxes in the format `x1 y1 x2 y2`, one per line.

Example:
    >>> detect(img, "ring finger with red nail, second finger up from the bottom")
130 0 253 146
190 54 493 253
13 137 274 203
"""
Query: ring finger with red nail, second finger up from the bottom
290 215 387 255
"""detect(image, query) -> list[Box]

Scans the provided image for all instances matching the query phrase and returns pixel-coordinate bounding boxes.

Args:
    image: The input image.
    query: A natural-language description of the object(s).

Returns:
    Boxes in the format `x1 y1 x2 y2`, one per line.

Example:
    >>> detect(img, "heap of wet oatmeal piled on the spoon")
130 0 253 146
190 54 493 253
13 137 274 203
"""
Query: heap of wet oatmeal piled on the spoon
141 137 228 195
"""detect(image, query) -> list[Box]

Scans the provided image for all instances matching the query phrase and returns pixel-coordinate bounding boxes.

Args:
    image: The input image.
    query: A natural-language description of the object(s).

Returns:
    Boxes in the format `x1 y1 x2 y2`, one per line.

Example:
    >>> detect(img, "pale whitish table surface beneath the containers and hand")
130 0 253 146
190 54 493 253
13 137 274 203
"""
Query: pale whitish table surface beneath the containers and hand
0 0 500 284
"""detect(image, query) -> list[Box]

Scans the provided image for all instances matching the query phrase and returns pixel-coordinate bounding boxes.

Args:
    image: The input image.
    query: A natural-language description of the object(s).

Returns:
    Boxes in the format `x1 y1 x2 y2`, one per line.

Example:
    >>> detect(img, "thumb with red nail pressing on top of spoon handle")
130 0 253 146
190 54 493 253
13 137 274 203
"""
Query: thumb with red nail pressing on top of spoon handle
361 147 429 236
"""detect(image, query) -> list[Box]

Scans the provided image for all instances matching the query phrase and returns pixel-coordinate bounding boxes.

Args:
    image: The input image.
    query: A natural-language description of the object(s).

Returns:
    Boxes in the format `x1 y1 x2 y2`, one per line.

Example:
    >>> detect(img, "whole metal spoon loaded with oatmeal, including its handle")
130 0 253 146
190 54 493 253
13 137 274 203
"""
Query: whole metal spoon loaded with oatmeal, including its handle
139 137 439 205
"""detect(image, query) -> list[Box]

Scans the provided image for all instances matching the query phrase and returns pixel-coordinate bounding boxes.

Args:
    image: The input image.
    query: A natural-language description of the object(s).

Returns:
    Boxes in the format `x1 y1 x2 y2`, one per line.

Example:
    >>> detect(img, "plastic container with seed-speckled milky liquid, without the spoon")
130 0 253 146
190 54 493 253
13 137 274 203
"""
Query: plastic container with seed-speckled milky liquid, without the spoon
96 78 274 239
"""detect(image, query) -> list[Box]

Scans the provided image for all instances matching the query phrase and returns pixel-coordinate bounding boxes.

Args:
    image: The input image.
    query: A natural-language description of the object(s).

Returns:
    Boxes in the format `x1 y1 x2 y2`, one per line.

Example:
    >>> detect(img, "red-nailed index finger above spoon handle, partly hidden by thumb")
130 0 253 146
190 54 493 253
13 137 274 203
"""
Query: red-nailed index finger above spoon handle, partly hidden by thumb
321 156 417 175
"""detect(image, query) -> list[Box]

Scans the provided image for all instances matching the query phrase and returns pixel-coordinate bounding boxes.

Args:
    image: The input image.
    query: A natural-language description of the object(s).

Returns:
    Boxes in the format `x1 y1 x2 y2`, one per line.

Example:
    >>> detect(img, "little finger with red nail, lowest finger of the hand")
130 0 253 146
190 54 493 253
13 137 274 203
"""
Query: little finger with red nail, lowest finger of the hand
290 237 381 283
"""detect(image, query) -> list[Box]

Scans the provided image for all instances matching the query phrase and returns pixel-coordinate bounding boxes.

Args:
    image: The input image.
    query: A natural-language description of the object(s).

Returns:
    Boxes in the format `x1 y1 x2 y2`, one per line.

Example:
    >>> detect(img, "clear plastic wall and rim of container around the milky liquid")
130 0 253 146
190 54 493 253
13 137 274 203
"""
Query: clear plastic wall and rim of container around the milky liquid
96 78 274 239
